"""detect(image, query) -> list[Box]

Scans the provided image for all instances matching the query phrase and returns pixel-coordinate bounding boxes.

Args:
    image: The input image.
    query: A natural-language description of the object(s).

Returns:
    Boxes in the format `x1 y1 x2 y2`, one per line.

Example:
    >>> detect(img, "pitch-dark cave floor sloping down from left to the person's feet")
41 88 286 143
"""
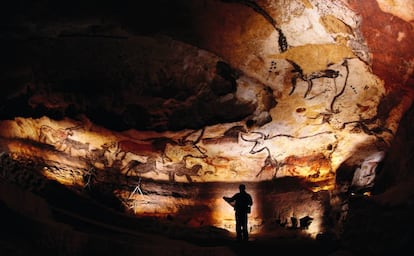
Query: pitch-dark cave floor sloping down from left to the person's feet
0 178 342 256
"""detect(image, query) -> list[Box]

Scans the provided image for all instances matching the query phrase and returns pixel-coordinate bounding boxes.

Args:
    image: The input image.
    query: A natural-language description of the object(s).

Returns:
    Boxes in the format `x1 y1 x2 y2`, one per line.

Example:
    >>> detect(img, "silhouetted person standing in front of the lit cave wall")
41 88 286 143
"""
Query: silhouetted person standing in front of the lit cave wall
223 184 253 241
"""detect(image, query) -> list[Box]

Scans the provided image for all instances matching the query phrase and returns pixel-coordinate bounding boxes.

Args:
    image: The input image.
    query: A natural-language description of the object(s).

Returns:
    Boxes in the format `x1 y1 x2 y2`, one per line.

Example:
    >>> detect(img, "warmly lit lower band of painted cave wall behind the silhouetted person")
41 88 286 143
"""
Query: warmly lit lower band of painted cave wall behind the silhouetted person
1 118 388 240
